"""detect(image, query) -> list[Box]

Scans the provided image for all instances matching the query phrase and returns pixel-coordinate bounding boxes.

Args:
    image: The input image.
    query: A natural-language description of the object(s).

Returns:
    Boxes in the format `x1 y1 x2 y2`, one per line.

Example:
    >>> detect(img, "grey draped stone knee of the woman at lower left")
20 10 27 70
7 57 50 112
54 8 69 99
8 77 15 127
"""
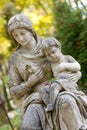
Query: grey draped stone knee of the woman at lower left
21 104 41 130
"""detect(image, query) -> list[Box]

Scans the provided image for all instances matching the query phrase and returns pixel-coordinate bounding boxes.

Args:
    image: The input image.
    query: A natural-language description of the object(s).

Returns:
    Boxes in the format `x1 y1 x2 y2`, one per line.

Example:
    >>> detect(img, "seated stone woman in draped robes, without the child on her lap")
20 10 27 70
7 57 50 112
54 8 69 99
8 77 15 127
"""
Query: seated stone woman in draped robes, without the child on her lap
8 14 85 130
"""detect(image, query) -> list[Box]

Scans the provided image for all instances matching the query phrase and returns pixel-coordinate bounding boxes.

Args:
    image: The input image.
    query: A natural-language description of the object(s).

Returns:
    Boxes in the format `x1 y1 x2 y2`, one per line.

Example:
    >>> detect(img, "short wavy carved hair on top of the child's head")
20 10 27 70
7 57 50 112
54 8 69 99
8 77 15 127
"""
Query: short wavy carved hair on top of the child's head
43 37 61 49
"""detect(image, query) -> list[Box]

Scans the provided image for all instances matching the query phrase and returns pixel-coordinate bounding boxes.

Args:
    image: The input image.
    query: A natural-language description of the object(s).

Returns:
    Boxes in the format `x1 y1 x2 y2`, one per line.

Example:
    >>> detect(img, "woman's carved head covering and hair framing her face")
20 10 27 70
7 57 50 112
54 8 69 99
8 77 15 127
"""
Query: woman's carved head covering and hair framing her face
8 14 37 48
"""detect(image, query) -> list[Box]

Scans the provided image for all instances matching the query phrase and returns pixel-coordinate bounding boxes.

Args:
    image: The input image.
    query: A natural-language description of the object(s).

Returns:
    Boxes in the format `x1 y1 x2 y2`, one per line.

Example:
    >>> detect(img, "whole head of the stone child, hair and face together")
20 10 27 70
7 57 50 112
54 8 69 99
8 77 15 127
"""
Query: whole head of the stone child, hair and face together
43 38 61 62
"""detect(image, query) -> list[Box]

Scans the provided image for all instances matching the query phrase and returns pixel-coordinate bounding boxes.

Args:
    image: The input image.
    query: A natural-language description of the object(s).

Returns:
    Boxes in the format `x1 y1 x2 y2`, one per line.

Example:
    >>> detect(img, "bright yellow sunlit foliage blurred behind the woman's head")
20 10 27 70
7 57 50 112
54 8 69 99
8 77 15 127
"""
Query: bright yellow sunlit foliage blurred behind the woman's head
0 0 54 61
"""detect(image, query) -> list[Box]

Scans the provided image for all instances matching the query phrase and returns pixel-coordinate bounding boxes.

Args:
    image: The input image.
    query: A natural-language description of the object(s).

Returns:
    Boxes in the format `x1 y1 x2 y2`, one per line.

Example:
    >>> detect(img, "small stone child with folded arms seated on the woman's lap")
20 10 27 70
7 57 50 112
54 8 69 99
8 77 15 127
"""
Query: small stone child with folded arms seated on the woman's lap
41 38 81 112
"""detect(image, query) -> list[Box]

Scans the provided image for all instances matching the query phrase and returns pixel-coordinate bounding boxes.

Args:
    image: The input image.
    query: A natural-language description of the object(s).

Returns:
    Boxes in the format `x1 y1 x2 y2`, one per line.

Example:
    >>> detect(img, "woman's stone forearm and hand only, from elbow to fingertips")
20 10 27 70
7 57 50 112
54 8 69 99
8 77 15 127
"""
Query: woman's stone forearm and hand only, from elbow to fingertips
10 70 43 98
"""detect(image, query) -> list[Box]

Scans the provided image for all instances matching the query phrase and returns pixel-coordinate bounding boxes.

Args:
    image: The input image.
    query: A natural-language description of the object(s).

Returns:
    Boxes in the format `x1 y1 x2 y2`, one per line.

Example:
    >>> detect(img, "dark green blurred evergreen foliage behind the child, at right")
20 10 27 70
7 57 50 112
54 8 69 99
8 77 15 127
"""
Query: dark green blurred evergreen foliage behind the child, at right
53 0 87 92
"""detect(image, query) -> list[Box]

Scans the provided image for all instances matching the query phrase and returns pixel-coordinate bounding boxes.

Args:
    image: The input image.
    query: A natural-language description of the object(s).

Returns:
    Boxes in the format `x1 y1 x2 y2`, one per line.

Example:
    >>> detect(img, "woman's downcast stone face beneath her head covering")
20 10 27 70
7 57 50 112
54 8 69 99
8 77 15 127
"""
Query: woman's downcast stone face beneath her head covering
12 28 33 46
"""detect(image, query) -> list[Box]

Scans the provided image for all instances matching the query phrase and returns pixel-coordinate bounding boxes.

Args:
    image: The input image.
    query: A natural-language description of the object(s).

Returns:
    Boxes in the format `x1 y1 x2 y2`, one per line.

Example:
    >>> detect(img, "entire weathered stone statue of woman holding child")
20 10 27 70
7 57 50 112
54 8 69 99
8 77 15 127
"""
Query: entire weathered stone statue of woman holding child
8 14 87 130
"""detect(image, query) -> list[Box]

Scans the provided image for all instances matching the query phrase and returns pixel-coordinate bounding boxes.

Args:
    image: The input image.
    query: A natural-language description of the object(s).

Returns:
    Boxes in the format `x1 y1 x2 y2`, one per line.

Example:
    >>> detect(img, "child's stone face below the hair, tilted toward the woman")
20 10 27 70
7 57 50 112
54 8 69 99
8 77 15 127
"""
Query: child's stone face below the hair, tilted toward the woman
44 46 60 62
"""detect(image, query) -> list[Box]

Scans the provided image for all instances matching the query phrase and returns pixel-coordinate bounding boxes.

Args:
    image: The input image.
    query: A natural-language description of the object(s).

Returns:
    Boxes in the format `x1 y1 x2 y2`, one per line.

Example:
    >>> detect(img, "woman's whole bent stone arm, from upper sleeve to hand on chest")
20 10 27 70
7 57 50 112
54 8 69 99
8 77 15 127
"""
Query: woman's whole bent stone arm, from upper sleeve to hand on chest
9 55 43 98
